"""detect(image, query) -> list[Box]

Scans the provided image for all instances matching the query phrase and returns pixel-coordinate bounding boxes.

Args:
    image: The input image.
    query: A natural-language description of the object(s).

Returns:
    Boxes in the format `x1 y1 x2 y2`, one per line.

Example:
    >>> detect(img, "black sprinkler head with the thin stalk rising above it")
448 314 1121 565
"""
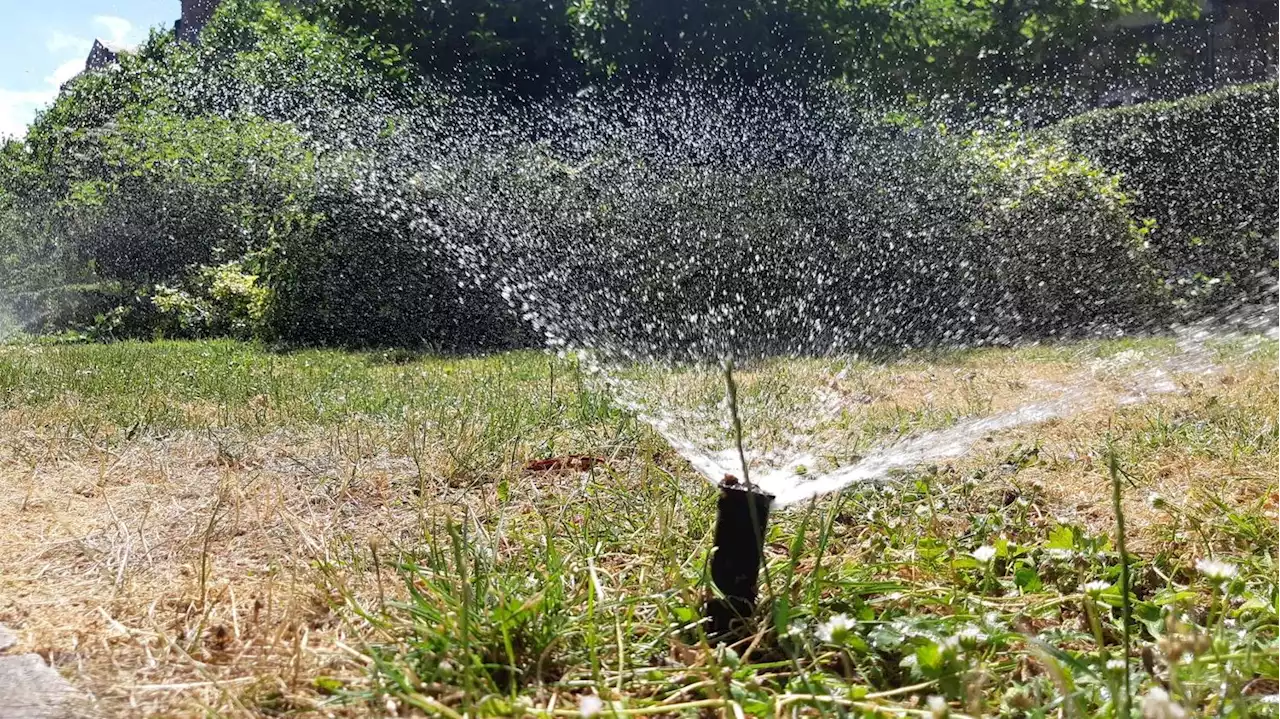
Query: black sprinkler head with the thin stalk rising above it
704 360 773 638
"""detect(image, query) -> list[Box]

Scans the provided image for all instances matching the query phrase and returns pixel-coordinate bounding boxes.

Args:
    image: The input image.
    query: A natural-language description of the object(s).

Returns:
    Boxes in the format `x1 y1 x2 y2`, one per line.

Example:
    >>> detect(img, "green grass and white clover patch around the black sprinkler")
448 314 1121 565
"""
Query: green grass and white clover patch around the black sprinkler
343 475 1280 716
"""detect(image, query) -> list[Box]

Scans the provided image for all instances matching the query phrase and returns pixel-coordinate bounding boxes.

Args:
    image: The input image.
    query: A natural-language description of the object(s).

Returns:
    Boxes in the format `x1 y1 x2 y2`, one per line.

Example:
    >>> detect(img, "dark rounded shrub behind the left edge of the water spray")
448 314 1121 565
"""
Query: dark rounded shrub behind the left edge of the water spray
257 168 529 351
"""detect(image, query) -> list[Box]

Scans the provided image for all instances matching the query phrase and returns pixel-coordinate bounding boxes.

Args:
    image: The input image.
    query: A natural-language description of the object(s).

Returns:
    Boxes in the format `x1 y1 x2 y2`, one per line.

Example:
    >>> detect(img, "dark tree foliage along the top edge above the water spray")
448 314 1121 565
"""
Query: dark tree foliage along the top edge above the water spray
302 0 1199 111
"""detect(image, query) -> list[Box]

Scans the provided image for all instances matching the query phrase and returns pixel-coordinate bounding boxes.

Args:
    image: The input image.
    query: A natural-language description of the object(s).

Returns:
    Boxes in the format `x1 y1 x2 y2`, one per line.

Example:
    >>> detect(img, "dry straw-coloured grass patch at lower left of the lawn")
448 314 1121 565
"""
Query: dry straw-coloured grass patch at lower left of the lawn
0 425 373 714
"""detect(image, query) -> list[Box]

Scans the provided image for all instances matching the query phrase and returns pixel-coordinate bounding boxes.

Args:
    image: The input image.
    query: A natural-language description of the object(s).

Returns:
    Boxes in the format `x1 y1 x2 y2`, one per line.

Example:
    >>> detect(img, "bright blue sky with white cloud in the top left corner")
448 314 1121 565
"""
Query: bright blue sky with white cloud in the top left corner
0 0 179 138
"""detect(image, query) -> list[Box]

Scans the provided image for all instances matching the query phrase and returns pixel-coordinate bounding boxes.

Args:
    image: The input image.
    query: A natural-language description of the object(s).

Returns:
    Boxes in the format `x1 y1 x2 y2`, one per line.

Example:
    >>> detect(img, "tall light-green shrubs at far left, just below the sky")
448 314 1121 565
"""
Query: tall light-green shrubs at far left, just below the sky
0 0 452 343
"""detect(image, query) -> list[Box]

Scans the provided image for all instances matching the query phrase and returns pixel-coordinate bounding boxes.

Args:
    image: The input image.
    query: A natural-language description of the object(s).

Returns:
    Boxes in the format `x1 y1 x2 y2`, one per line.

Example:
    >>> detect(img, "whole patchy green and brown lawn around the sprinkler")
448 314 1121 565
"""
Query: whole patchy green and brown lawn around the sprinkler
0 339 1280 718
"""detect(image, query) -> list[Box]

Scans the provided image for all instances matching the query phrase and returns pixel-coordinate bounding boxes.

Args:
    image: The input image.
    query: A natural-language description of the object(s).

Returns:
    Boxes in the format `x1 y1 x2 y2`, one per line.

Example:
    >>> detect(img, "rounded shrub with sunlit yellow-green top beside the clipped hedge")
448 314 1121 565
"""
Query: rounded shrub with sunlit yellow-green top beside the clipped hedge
959 134 1165 334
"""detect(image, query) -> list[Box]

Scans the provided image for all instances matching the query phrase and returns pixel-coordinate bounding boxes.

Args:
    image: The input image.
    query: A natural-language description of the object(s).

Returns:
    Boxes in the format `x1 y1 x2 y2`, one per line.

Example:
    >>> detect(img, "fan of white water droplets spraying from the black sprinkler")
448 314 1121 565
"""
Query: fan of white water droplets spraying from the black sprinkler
363 79 1274 505
